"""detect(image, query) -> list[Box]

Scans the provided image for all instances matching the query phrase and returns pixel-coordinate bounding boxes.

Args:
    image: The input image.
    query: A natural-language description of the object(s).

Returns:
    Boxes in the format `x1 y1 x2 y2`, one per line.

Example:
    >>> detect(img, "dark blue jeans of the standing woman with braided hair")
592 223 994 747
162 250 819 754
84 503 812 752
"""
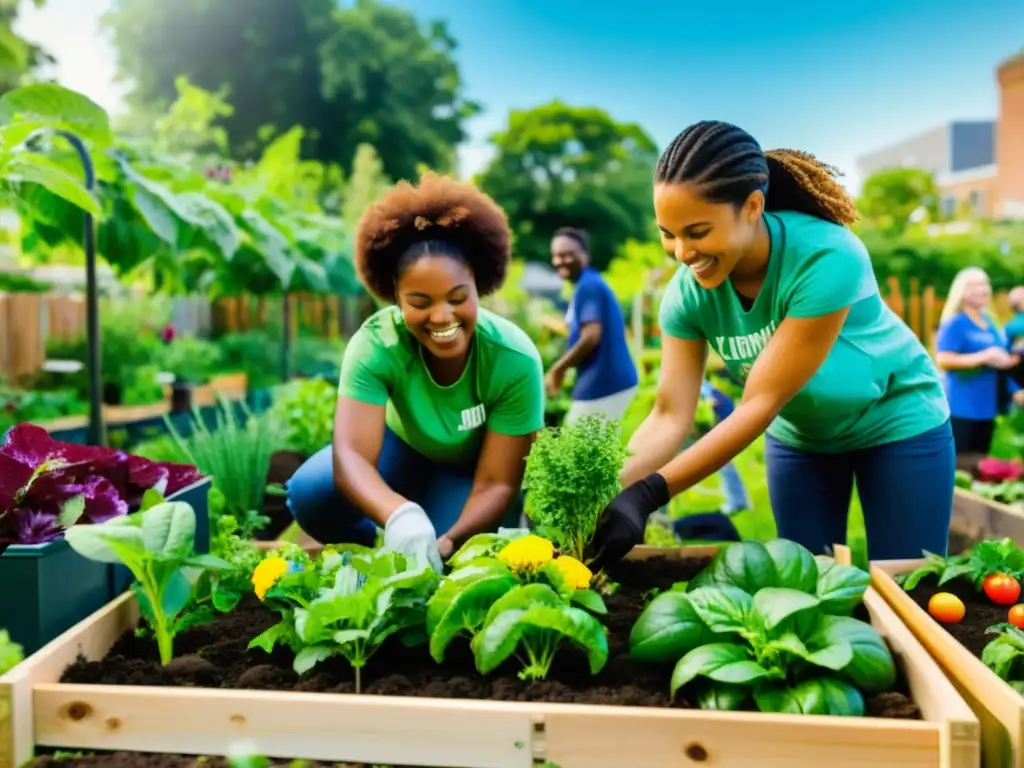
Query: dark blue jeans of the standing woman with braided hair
765 421 956 560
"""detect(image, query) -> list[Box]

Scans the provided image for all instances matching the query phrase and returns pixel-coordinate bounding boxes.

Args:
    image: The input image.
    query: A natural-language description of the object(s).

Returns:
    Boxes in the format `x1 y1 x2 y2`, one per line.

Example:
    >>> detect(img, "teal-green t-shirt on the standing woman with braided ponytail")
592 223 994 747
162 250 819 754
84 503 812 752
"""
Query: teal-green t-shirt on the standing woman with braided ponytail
660 211 949 453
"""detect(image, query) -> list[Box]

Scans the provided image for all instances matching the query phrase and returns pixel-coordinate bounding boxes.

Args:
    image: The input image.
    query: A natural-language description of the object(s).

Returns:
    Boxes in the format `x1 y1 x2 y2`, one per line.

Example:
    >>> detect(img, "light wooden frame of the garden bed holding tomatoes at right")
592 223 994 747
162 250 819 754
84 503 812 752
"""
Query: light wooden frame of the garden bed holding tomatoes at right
871 559 1024 768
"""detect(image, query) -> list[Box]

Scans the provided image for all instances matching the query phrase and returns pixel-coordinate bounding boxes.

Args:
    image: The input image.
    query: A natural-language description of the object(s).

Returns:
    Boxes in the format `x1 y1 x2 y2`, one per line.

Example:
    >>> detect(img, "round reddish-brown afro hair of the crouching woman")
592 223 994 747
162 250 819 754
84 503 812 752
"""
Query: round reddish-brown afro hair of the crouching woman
355 171 511 302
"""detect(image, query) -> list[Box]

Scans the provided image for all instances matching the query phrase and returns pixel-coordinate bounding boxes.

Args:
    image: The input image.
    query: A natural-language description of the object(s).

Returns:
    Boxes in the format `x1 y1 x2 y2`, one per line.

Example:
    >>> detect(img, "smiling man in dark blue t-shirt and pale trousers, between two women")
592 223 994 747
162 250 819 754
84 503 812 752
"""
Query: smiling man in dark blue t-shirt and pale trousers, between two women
545 227 638 423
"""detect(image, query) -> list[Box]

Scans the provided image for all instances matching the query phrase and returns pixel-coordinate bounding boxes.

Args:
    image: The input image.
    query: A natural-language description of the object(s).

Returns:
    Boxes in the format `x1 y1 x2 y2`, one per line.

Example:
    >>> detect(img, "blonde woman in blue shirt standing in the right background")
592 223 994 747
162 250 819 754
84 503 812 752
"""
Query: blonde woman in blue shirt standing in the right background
935 266 1020 455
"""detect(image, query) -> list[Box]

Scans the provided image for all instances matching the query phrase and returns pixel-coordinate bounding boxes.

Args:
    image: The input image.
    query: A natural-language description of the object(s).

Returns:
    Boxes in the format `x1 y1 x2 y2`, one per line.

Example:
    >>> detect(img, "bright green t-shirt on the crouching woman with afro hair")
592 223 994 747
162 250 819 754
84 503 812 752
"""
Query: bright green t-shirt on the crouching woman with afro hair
339 306 544 464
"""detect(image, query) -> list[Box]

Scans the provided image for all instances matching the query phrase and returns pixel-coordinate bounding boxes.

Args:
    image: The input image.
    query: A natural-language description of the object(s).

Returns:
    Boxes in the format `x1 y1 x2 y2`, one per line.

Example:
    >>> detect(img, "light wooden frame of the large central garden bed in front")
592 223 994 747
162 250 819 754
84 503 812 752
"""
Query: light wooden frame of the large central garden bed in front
0 547 979 768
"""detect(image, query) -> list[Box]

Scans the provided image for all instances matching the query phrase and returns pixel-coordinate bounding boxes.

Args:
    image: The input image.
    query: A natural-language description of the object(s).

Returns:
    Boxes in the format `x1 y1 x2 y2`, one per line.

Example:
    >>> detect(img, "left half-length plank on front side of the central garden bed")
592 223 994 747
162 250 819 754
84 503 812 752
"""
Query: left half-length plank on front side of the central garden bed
35 684 534 768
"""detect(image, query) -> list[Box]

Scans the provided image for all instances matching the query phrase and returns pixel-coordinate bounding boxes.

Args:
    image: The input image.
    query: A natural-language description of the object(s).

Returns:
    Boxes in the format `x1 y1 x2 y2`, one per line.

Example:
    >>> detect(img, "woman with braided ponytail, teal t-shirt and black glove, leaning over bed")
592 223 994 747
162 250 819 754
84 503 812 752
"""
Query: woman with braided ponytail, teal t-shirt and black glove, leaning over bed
596 122 955 567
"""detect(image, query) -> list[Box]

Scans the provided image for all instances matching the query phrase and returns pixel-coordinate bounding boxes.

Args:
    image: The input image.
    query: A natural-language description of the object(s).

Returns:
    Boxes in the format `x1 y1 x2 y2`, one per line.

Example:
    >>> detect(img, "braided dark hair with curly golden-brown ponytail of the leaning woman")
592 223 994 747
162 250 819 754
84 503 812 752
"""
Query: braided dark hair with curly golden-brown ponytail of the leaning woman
654 120 859 226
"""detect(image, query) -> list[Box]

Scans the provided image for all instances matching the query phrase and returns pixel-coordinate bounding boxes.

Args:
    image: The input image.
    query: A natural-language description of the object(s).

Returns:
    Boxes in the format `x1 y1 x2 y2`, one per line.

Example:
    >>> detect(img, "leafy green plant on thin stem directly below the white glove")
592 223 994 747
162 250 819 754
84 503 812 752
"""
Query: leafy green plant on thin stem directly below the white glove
250 552 438 693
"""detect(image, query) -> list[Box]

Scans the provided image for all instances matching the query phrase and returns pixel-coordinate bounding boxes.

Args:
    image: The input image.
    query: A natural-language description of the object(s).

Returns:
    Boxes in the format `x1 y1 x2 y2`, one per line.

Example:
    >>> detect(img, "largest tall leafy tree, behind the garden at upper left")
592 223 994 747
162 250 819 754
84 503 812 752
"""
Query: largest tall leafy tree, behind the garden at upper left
105 0 477 178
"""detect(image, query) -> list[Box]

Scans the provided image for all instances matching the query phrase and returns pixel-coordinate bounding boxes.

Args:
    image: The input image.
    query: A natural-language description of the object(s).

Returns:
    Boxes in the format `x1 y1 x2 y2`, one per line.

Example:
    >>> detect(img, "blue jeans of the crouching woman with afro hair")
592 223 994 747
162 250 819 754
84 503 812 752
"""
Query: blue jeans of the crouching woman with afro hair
287 429 522 547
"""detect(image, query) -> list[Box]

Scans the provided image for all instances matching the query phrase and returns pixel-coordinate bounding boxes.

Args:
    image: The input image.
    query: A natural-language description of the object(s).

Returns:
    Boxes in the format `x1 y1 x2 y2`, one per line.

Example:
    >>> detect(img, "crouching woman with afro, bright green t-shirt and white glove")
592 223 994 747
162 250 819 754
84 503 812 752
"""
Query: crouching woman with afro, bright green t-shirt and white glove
288 173 544 570
